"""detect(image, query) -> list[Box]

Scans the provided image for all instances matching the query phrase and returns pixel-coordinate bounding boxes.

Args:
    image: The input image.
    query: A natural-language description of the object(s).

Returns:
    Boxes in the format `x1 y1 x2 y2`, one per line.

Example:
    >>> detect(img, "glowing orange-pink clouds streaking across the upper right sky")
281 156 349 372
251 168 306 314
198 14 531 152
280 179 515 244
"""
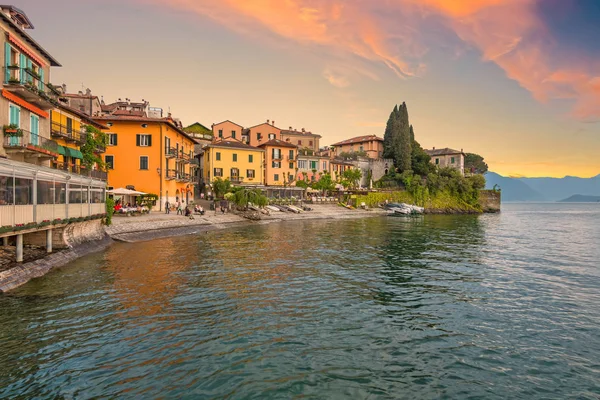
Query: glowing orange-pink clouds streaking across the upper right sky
137 0 600 119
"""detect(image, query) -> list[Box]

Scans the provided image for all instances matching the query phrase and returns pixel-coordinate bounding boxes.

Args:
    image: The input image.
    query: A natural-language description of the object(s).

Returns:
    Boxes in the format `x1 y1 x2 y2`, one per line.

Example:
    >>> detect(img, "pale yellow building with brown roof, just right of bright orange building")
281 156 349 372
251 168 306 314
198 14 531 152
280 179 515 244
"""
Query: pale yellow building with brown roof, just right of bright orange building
202 138 265 186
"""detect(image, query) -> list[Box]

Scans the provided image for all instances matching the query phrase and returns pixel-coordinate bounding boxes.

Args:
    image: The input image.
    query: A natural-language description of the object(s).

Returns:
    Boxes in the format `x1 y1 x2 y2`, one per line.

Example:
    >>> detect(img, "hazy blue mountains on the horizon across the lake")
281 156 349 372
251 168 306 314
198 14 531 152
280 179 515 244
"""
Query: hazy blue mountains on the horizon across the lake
485 172 600 201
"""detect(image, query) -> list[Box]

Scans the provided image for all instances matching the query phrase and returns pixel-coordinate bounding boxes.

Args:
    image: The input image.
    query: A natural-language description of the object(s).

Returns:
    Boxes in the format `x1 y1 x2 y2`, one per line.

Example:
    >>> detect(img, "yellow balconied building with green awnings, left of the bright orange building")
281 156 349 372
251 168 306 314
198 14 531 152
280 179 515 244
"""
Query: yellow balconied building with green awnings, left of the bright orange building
50 104 108 180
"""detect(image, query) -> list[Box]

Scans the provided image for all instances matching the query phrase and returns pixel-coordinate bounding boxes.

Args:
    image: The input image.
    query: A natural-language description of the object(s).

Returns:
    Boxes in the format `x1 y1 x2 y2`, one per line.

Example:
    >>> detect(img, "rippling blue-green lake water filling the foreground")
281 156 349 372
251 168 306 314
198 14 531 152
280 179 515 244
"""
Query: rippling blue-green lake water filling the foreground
0 204 600 399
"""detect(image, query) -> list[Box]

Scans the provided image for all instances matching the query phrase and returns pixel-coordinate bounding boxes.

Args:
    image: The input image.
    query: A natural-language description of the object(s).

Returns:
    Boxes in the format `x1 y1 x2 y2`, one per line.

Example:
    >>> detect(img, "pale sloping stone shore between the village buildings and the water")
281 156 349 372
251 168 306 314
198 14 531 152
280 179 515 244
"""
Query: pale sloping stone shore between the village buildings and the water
106 205 383 242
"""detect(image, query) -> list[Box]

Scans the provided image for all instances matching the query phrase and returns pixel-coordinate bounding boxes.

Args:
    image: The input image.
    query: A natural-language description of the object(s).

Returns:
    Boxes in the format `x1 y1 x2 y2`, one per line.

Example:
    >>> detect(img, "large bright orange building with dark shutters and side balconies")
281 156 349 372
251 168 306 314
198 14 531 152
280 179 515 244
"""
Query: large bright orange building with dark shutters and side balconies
94 115 197 206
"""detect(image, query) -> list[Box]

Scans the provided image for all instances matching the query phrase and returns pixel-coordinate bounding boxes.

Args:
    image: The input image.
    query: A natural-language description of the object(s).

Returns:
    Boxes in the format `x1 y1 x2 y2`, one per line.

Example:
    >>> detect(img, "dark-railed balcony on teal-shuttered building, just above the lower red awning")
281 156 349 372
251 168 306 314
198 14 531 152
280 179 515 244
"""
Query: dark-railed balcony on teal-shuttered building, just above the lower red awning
4 66 58 110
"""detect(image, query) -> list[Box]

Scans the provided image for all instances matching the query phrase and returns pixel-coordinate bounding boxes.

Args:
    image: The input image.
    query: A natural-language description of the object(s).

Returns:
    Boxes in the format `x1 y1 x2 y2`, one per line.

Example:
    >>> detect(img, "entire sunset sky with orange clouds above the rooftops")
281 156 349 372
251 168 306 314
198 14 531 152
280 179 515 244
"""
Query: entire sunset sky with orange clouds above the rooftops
13 0 600 177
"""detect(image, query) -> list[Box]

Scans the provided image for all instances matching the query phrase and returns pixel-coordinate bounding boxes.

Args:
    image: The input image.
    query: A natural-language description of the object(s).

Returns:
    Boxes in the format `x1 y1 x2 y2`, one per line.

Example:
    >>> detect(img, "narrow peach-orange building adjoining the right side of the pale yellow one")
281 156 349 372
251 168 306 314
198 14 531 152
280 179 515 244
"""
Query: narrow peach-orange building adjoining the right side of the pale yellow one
258 139 298 186
